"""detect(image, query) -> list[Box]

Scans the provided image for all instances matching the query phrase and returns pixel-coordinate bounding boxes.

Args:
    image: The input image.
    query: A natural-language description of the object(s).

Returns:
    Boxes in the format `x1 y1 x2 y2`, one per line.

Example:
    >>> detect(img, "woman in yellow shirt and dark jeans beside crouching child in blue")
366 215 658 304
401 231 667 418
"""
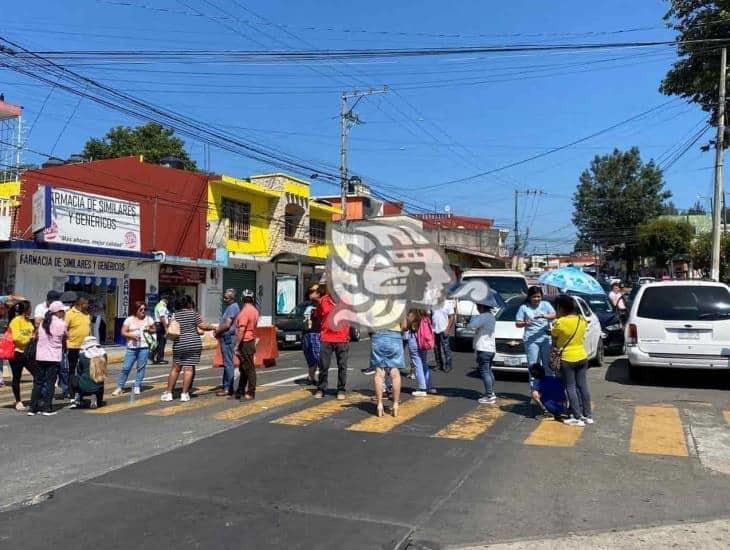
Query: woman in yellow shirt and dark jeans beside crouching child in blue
551 294 593 427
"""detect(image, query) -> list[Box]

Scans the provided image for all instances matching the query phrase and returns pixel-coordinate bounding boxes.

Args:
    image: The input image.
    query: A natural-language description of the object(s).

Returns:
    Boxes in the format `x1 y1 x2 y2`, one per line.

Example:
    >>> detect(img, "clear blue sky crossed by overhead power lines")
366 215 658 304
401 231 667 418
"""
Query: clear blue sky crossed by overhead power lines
0 0 713 252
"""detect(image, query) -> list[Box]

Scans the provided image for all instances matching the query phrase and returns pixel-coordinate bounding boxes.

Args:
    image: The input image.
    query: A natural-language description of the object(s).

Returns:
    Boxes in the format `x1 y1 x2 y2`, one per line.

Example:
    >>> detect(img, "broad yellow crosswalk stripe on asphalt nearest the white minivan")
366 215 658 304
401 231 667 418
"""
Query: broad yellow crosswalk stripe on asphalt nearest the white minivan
630 406 689 456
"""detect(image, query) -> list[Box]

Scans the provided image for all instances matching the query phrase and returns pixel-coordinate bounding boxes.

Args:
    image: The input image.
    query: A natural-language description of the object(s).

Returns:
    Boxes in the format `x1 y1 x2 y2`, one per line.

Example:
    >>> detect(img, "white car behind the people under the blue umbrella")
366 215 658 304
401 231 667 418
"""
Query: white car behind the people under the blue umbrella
492 296 603 372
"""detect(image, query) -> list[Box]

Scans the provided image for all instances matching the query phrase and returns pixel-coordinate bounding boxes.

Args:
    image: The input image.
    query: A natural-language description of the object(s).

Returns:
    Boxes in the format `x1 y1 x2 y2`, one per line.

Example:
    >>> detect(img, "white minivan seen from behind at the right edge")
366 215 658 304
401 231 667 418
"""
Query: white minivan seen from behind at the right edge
625 281 730 378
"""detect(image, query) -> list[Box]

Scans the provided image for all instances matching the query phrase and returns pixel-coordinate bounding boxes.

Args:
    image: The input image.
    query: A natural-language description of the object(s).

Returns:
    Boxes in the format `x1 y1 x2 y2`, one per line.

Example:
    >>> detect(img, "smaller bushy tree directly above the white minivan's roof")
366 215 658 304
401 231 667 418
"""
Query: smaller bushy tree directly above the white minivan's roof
637 218 694 267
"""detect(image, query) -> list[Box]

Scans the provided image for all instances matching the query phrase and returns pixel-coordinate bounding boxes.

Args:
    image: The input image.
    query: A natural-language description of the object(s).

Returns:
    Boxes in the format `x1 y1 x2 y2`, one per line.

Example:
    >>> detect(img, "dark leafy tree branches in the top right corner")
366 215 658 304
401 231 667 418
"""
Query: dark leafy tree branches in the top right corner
659 0 730 147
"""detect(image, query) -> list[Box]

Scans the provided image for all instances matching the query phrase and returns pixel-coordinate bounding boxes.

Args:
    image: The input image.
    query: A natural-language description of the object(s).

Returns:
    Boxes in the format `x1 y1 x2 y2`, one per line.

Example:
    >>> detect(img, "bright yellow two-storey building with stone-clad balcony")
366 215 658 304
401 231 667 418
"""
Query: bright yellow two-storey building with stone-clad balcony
208 174 340 324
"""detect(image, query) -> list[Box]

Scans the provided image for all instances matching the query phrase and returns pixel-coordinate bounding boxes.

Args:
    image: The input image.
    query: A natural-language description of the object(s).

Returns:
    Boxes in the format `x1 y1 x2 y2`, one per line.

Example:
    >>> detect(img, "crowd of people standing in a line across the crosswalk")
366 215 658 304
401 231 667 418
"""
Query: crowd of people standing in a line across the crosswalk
4 284 593 426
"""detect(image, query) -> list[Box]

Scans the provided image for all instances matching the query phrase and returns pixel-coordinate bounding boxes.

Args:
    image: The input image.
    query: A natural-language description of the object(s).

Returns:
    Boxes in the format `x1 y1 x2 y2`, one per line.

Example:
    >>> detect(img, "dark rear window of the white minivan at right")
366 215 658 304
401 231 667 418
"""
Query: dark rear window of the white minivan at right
636 285 730 321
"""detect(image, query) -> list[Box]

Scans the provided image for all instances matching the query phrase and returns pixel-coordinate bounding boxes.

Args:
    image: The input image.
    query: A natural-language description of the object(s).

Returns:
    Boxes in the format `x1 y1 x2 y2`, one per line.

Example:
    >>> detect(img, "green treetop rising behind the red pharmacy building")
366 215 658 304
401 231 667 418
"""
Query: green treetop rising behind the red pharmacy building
84 122 197 170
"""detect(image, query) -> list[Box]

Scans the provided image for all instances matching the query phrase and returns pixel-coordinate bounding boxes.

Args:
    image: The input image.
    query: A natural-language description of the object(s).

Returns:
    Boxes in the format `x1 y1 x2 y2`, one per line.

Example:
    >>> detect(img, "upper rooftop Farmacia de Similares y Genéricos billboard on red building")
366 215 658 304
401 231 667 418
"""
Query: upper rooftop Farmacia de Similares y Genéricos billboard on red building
33 186 141 252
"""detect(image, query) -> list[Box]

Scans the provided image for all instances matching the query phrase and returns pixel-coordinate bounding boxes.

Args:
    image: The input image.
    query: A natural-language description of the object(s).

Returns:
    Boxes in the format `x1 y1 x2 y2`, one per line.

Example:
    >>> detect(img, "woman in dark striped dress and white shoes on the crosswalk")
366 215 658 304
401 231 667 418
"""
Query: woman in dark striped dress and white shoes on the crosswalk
160 296 215 401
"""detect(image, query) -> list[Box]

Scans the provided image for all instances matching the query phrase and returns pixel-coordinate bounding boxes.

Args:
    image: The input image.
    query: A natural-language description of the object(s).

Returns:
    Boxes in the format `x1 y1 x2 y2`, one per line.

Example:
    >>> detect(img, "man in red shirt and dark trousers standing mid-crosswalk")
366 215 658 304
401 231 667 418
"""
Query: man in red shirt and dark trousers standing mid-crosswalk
309 285 350 400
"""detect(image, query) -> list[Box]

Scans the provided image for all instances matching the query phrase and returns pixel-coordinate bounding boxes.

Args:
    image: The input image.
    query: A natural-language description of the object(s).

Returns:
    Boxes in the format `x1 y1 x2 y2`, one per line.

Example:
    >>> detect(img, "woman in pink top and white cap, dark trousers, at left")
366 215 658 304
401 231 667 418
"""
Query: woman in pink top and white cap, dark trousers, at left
28 301 68 416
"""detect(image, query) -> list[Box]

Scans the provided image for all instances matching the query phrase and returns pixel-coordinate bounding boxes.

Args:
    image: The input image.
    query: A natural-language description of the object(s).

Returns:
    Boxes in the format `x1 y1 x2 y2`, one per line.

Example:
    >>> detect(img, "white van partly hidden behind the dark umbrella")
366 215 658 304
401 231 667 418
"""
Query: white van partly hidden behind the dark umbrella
454 269 527 347
